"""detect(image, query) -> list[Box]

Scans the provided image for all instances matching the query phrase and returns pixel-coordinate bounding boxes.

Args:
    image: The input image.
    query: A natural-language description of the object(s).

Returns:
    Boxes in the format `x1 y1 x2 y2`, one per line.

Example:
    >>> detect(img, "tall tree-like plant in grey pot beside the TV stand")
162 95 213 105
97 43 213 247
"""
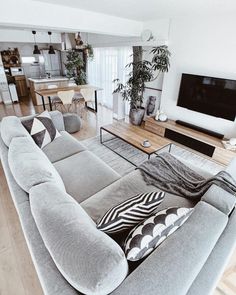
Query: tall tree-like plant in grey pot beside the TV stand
114 45 170 125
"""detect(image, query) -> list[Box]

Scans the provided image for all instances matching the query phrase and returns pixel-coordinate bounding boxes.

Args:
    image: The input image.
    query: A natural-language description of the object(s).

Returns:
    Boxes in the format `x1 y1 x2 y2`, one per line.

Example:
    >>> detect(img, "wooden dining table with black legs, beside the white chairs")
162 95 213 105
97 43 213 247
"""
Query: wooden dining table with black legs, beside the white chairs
35 85 102 112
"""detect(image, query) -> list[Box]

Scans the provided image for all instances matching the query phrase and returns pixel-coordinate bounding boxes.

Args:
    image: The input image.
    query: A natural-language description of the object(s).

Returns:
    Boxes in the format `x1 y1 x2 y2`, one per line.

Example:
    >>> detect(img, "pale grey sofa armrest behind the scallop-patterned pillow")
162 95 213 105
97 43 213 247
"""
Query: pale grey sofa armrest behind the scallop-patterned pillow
112 201 228 295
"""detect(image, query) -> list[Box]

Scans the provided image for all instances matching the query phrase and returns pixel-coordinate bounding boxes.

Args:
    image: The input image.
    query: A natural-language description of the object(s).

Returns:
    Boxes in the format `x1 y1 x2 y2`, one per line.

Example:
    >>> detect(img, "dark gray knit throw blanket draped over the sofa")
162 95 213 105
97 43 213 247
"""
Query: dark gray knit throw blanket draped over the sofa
137 153 236 200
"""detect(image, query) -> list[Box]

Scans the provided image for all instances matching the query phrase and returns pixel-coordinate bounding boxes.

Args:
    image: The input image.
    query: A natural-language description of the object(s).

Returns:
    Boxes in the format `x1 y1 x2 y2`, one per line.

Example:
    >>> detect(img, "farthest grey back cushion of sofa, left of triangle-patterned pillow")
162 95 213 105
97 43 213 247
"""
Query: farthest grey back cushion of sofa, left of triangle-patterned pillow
1 116 31 147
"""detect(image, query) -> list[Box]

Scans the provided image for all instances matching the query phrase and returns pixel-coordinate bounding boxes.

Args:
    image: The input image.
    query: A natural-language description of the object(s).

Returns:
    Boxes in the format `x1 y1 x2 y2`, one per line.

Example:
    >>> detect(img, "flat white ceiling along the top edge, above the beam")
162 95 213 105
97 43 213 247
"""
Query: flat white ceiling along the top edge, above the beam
32 0 236 21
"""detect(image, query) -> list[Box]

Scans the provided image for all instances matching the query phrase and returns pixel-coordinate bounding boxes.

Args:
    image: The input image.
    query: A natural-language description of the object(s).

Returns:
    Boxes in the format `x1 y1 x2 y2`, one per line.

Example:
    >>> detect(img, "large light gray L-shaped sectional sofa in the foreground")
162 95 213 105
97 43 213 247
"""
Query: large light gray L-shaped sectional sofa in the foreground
0 111 236 295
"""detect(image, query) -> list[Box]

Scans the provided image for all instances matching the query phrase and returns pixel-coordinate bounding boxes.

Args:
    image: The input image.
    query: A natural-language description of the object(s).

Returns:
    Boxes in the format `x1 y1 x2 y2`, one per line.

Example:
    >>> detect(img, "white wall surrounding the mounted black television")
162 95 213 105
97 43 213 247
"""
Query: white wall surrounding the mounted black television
162 16 236 137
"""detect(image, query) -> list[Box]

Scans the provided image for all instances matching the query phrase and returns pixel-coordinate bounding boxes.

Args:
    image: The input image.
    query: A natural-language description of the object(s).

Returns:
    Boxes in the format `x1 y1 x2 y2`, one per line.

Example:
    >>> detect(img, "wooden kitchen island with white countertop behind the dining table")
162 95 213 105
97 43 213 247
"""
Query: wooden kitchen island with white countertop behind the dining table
28 76 69 105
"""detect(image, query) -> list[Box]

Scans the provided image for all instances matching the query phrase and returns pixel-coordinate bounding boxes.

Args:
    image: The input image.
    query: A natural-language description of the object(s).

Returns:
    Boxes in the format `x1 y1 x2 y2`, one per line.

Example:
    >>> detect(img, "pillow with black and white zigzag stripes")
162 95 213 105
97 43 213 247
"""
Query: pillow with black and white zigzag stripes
97 191 165 233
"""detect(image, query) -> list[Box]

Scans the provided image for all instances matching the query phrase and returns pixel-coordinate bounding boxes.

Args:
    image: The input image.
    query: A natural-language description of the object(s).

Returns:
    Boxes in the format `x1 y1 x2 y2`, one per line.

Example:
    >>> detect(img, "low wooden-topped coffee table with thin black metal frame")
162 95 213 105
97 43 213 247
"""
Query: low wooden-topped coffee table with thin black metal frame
100 121 172 166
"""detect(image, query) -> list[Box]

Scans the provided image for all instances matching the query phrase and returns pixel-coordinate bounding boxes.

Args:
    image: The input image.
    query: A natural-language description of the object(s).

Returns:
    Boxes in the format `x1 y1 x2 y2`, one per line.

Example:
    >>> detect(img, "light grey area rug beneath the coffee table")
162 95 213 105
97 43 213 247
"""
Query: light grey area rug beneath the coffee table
82 135 224 176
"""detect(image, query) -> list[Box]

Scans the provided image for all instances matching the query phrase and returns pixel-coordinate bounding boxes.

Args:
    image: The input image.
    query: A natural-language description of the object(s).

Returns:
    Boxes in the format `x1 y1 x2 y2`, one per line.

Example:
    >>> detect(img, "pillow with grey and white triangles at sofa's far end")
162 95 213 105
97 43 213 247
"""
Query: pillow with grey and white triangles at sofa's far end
22 111 61 149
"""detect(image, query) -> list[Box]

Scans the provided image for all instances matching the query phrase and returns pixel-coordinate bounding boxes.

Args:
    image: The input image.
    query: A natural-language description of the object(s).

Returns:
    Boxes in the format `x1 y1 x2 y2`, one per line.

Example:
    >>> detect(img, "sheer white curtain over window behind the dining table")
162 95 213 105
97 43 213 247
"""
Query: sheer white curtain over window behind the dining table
87 47 133 108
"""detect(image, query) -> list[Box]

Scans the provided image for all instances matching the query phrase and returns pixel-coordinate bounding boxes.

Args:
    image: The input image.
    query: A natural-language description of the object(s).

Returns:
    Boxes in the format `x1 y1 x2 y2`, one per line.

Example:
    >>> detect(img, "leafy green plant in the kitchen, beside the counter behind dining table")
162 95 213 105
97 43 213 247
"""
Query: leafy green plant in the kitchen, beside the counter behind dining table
65 49 86 85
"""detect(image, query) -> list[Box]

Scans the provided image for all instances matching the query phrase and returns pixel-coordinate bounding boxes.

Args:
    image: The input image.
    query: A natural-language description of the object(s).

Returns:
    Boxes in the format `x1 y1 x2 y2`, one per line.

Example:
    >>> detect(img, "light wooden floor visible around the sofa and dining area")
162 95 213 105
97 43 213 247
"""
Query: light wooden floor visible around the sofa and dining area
0 98 236 295
